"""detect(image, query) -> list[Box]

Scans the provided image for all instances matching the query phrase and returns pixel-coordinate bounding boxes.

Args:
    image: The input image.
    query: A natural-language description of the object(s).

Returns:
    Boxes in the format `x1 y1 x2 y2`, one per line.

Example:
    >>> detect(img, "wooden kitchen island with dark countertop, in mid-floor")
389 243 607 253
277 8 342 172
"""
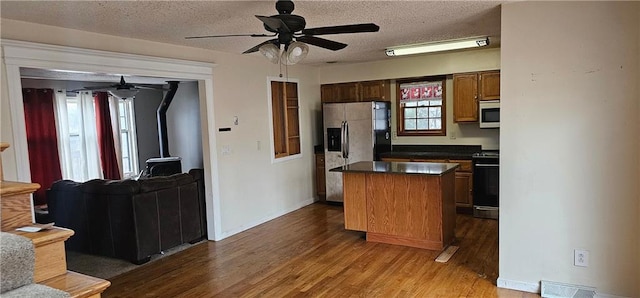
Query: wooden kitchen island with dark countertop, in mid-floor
331 161 458 250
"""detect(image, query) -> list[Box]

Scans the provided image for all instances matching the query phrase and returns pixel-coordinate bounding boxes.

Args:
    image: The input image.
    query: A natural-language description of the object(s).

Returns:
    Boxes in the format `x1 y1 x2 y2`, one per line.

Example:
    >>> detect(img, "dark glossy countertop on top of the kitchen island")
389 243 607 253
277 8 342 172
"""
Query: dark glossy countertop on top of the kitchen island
330 161 458 176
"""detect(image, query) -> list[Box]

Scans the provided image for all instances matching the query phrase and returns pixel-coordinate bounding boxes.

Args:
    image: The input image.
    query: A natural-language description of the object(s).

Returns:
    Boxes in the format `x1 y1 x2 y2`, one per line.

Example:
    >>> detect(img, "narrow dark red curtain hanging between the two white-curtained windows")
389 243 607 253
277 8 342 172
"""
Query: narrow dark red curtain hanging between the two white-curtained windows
94 92 120 180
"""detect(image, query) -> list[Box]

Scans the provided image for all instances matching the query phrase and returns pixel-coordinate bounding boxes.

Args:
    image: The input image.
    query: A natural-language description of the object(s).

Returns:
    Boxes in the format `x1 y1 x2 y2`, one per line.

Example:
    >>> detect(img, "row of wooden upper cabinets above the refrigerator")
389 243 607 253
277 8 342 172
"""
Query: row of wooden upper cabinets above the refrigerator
320 80 391 102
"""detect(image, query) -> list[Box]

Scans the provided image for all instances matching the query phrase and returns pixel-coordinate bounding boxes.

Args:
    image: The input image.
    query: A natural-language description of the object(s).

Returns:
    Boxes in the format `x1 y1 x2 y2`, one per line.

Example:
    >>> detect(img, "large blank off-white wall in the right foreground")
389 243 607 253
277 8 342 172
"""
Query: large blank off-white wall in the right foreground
498 2 640 297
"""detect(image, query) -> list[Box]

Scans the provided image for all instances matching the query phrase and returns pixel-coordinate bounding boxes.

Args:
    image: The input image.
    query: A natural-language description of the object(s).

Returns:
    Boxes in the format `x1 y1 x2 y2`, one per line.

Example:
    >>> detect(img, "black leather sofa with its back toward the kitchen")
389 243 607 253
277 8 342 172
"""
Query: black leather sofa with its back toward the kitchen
47 169 206 264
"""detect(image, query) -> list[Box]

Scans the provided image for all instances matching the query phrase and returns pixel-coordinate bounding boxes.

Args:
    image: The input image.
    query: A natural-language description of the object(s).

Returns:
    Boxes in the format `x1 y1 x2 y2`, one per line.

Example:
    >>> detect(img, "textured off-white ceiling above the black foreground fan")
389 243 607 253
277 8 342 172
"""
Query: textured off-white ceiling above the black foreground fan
0 0 505 65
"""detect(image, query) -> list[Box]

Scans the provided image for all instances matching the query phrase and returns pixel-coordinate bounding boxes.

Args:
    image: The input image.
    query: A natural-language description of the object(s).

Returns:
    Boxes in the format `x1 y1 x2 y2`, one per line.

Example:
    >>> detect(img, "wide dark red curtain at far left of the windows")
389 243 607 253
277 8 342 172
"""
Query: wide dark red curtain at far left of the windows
22 88 62 206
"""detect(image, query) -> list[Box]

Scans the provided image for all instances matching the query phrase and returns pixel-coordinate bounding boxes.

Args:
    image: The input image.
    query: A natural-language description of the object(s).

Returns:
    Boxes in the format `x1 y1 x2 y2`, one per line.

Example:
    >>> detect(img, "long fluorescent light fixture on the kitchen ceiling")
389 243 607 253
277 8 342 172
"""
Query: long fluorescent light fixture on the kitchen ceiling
386 37 489 56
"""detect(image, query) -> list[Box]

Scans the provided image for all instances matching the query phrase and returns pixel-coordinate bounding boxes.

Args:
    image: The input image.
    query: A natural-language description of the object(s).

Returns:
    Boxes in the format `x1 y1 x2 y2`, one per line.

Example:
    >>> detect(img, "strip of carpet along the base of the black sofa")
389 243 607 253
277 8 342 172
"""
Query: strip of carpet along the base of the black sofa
66 240 206 279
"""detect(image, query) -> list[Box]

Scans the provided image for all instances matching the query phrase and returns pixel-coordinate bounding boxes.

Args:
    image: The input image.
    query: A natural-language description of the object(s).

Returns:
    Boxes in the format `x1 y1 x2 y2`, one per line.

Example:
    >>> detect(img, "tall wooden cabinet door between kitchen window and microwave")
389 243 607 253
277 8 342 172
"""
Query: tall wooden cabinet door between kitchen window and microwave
453 73 478 122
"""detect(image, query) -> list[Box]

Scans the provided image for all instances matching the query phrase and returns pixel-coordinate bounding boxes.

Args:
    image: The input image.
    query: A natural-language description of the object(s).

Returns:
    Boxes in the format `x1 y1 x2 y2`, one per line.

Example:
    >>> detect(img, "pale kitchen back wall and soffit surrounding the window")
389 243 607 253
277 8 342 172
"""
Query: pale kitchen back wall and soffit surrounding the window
320 48 500 149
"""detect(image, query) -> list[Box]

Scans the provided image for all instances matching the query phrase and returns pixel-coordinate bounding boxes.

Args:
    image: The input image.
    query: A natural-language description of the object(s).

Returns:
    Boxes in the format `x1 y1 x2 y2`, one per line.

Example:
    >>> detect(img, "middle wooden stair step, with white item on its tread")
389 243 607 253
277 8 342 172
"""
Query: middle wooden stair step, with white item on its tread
10 227 74 282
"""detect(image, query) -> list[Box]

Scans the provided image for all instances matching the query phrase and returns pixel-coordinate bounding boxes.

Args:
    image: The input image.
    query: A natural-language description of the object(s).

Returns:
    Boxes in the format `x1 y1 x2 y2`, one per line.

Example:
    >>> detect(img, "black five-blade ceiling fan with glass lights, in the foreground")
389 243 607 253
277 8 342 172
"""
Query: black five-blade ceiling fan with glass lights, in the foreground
185 0 380 65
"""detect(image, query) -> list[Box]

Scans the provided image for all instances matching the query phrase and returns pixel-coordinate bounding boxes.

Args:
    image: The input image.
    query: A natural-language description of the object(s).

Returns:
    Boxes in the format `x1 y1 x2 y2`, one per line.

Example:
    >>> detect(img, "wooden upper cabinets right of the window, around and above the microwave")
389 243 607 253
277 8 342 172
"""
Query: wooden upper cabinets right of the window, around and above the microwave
453 70 500 122
